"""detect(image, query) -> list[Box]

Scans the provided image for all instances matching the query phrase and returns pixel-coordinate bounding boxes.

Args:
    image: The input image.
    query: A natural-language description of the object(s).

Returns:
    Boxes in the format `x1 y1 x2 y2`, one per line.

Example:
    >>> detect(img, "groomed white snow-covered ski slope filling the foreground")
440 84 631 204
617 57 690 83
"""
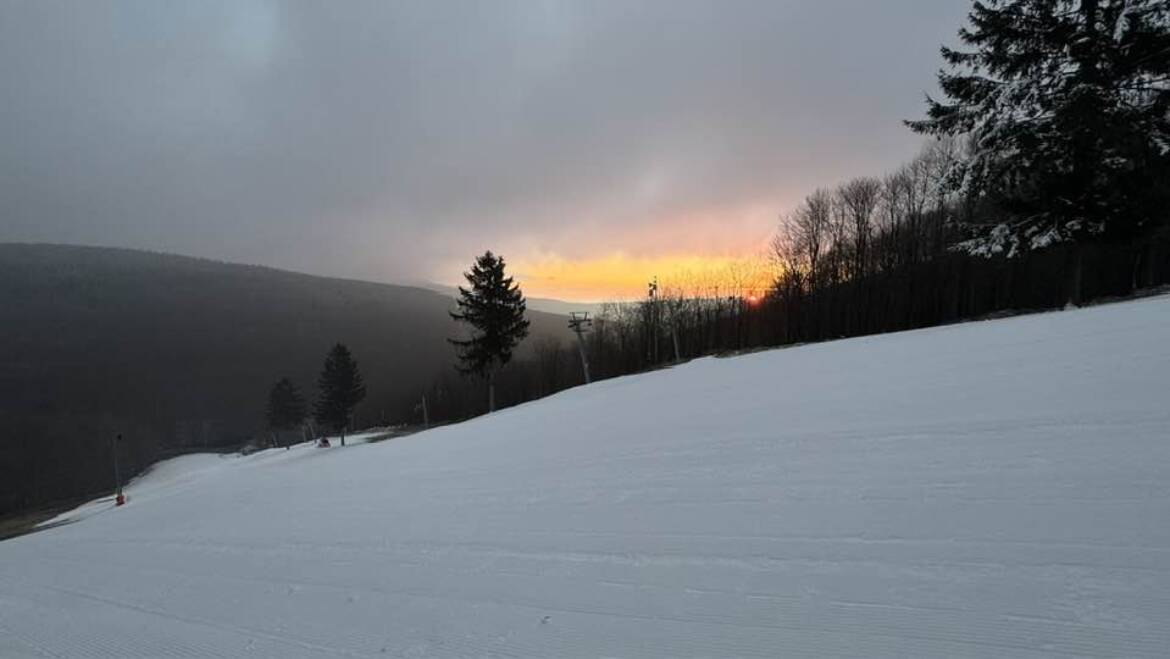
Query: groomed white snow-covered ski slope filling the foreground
0 297 1170 657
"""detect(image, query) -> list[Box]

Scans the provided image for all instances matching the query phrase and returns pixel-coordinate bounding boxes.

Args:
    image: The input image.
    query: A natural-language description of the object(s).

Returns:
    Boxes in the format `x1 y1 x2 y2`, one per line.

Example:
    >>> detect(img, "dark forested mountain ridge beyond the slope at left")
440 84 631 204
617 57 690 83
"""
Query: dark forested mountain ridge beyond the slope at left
0 243 567 512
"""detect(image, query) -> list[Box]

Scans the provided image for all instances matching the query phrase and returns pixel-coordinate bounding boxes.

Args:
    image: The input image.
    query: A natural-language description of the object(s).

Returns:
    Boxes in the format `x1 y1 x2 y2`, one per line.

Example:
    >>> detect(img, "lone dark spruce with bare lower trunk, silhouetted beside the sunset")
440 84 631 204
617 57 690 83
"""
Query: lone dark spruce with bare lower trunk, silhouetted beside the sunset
449 252 528 412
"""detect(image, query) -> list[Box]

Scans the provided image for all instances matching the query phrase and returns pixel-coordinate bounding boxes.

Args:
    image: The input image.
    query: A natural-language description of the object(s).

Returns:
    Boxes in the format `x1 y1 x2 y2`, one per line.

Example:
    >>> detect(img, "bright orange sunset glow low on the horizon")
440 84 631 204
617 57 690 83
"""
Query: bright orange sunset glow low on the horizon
511 253 773 302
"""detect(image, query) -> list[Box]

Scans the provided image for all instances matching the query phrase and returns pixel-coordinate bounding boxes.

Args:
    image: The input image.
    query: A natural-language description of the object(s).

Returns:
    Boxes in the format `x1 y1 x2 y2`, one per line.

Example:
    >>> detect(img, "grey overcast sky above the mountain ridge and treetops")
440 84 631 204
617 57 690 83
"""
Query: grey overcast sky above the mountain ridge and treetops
0 0 970 295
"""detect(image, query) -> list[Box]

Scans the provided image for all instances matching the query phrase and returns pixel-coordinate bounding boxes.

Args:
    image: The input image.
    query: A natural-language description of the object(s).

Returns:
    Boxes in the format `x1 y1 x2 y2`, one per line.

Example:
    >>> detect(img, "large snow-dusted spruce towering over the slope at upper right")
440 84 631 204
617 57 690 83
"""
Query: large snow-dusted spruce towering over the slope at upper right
908 0 1170 254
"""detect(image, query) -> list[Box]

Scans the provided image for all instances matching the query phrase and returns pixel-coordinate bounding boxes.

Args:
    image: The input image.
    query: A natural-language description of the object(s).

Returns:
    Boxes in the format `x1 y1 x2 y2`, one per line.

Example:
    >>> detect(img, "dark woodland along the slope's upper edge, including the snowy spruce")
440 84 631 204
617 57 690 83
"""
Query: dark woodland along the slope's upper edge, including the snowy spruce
414 0 1170 418
